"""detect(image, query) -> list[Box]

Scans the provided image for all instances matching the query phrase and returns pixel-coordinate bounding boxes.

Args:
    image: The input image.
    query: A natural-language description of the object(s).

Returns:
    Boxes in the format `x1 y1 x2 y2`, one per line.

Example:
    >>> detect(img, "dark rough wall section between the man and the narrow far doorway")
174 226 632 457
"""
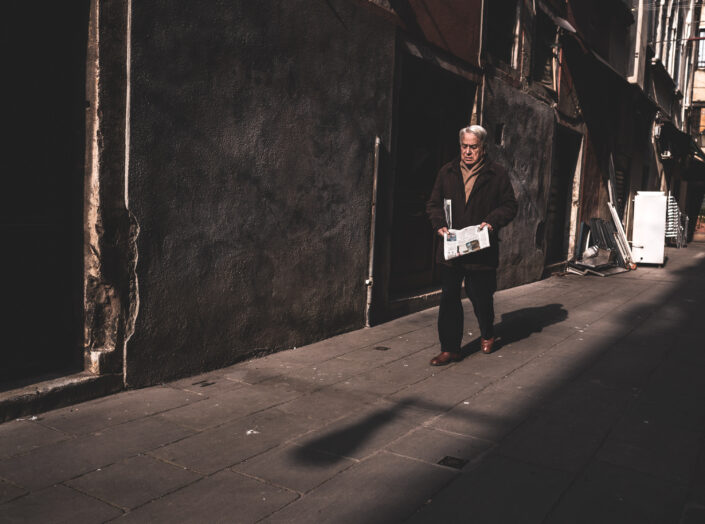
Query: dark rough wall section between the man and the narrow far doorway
483 75 554 288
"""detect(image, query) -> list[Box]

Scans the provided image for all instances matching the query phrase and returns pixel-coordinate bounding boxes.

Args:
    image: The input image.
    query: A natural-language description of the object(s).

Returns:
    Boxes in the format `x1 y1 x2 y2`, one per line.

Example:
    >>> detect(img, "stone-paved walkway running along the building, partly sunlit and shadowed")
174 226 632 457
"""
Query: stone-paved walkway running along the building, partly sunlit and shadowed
0 243 705 524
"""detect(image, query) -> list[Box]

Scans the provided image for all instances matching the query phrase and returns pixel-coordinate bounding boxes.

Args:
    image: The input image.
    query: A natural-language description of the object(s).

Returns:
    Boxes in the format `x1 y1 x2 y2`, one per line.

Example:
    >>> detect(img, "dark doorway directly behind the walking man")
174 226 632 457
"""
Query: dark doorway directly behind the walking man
389 54 476 297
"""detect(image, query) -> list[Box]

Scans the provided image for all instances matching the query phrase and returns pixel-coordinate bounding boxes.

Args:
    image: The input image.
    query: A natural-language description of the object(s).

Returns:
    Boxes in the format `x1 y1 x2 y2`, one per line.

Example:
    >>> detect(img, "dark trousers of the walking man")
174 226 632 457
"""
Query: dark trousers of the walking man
438 265 497 353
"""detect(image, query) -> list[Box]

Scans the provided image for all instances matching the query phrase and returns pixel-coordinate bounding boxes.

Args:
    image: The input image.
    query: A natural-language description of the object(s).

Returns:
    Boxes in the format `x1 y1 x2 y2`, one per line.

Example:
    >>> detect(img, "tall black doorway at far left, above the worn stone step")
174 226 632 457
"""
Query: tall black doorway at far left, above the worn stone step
0 0 90 382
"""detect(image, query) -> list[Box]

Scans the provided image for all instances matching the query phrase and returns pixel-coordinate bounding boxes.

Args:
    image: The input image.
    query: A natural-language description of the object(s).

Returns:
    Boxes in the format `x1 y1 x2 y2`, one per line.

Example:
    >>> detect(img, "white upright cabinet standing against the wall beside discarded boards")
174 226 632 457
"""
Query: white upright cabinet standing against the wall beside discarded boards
632 191 666 264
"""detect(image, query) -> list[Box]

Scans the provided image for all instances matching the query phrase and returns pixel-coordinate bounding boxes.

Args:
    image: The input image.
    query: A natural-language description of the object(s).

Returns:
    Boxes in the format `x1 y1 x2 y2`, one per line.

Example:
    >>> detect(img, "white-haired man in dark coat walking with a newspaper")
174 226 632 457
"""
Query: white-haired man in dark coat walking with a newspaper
426 126 517 366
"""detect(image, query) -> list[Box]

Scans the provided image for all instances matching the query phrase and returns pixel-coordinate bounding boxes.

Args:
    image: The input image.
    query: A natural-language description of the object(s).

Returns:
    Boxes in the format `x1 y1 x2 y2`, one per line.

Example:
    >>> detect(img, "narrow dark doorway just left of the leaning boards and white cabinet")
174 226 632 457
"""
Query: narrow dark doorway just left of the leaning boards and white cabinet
546 125 582 266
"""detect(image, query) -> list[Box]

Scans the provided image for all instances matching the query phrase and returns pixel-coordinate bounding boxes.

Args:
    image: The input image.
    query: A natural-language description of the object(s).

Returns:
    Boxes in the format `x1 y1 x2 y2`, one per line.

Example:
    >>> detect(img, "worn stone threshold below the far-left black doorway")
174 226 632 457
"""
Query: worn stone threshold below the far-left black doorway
0 371 124 423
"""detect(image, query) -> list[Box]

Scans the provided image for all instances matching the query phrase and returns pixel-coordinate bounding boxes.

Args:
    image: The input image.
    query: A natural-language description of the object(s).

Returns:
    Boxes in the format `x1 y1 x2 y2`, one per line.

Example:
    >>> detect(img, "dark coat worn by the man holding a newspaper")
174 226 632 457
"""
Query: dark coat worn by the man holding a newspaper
426 157 517 269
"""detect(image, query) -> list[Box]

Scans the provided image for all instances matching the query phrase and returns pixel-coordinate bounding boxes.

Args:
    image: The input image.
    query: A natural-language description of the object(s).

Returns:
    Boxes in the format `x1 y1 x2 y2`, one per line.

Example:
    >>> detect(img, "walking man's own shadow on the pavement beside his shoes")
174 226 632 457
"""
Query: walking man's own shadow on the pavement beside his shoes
461 304 568 357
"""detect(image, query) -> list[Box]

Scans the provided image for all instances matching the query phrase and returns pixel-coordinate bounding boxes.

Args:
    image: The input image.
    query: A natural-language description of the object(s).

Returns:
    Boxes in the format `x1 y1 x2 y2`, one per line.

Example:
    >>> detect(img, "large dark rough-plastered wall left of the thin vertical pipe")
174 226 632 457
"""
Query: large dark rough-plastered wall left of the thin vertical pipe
127 0 394 386
